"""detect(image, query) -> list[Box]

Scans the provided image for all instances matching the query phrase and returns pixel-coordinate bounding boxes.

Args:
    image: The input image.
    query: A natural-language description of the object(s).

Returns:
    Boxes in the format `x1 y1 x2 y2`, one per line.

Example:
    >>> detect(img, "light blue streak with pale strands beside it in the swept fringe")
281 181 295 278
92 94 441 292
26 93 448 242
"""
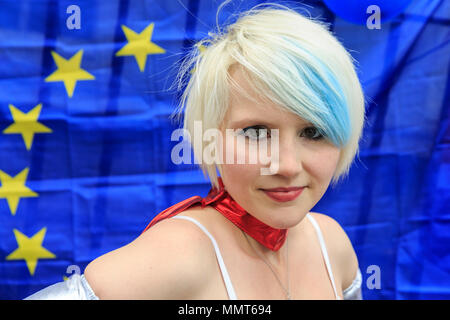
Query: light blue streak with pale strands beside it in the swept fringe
268 39 351 148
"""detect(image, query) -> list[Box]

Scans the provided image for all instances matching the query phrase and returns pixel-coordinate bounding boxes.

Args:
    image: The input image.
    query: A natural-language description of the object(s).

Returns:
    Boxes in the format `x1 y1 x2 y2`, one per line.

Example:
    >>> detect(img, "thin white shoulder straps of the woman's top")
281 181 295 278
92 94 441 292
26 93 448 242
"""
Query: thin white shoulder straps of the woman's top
171 213 362 300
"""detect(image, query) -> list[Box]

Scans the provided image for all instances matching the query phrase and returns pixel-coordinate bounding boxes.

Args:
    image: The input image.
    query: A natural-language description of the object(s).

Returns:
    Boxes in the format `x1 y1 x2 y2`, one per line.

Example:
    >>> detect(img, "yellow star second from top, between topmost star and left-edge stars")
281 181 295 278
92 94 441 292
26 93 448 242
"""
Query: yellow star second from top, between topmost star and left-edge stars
45 50 95 98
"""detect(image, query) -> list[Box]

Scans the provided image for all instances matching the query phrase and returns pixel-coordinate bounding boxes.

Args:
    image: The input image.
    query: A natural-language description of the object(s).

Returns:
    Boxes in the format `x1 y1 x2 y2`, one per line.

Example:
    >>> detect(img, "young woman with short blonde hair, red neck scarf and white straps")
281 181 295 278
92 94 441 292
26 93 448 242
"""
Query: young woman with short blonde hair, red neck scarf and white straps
25 6 364 299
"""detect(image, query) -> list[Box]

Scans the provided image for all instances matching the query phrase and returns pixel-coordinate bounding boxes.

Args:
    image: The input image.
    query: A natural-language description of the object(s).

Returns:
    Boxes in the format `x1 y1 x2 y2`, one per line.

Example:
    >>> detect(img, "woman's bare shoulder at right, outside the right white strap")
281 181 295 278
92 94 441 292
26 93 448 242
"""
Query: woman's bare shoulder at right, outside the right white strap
309 212 359 290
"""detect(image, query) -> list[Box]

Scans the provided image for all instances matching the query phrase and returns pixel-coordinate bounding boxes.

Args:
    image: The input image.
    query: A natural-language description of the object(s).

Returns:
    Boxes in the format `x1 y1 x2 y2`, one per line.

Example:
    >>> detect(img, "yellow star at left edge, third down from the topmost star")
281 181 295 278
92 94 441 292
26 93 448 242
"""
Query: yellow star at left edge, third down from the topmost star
3 103 52 150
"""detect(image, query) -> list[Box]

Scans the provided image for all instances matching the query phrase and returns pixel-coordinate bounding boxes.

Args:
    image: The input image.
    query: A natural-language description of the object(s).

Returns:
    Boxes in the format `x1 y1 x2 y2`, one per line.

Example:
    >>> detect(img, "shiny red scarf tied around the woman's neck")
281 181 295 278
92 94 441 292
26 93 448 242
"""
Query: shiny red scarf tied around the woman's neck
144 178 287 251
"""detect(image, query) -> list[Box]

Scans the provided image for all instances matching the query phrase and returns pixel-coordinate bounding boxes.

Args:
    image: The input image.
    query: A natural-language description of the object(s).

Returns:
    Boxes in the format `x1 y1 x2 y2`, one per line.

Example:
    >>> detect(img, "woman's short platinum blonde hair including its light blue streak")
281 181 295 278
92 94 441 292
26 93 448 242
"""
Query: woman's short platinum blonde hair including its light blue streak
172 4 364 186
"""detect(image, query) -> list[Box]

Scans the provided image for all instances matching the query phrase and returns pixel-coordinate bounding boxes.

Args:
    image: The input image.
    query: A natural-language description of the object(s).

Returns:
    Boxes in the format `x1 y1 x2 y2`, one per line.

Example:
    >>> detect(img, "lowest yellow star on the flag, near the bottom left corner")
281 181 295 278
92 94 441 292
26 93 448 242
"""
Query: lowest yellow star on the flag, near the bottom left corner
6 228 56 275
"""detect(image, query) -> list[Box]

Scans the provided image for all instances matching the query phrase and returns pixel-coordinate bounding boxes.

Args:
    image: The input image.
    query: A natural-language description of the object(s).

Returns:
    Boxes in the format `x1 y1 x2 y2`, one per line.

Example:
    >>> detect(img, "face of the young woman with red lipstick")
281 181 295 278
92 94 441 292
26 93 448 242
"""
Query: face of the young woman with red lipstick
220 68 340 229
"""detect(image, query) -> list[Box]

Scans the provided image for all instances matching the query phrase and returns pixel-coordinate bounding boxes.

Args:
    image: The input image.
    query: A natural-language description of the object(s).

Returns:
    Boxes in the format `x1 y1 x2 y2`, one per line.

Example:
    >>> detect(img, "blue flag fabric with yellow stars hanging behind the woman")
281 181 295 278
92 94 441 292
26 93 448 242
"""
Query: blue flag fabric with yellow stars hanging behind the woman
0 0 450 299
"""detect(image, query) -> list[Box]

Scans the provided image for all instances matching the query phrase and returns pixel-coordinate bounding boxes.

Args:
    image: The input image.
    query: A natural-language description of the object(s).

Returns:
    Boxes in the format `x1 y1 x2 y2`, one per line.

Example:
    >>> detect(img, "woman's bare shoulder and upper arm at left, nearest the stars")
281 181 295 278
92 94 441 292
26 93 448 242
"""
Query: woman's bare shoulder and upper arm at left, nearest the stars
84 212 220 299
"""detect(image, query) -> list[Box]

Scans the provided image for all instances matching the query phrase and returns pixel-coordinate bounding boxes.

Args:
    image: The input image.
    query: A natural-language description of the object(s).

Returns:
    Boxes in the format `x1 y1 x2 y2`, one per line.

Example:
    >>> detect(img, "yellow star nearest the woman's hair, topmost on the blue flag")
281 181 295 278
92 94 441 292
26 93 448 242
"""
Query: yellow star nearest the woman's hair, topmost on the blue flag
116 23 166 72
